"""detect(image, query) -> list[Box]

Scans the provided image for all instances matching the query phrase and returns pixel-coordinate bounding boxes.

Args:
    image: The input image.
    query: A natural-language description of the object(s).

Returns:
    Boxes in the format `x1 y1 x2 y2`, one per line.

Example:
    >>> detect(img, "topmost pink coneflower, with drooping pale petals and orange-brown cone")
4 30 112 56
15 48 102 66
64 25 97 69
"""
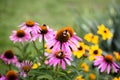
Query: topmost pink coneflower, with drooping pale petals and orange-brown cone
20 20 39 33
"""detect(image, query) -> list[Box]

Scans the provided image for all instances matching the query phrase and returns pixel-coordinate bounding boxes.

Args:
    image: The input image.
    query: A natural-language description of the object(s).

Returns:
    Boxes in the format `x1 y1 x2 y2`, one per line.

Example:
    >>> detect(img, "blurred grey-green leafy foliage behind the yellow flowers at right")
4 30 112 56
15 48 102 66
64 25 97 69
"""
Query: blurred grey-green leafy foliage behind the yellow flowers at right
75 3 120 53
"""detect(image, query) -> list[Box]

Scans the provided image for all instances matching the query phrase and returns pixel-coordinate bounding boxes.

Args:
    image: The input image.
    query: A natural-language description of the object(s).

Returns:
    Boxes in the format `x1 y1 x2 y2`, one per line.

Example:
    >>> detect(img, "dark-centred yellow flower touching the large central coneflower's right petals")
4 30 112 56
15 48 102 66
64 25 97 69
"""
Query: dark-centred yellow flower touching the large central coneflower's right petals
73 42 85 58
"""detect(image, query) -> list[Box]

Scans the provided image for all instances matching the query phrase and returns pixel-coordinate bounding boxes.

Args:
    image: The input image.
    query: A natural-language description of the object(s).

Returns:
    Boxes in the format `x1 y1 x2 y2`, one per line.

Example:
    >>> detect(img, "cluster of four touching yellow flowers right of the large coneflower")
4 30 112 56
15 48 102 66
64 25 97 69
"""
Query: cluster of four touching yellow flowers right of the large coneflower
73 24 113 61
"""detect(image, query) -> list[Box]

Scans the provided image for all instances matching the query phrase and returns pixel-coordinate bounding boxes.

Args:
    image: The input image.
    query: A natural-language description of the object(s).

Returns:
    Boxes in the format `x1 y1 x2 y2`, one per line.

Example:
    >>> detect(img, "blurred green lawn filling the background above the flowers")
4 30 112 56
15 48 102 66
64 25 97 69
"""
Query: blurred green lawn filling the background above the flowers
0 0 120 53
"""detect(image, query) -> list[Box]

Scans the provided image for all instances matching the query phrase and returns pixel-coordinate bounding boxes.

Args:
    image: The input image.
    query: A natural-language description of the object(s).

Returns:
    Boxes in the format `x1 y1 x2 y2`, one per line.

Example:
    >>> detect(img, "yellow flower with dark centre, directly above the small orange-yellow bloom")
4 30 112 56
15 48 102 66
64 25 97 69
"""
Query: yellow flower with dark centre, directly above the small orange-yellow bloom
89 45 102 60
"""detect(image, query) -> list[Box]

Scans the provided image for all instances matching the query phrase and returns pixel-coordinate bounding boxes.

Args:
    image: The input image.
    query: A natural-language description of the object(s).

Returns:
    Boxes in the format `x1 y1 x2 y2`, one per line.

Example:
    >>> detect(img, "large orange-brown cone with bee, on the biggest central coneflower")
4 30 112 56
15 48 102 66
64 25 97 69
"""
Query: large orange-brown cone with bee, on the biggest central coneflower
56 29 70 43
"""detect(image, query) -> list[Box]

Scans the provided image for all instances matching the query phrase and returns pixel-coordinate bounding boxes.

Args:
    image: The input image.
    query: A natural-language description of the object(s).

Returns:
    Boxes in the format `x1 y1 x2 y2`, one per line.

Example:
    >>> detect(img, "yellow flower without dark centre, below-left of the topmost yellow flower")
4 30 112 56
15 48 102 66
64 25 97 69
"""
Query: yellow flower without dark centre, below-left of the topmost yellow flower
84 33 98 44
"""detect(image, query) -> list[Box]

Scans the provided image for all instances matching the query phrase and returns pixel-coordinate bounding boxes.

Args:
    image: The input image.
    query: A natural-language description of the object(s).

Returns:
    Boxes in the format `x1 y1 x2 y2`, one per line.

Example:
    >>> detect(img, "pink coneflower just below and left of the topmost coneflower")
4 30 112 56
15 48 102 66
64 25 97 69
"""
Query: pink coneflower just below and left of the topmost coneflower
10 30 30 43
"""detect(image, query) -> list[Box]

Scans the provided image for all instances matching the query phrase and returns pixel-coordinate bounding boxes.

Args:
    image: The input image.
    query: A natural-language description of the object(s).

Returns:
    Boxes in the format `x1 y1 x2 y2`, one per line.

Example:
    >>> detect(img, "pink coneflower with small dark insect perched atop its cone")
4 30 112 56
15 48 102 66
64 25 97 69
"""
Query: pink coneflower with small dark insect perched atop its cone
32 24 54 42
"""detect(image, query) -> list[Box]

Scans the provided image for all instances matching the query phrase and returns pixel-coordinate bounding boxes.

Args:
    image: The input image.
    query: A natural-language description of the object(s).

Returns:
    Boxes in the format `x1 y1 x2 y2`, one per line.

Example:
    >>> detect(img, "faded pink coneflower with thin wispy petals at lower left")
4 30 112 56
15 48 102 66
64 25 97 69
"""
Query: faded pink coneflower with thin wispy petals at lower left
19 60 33 77
